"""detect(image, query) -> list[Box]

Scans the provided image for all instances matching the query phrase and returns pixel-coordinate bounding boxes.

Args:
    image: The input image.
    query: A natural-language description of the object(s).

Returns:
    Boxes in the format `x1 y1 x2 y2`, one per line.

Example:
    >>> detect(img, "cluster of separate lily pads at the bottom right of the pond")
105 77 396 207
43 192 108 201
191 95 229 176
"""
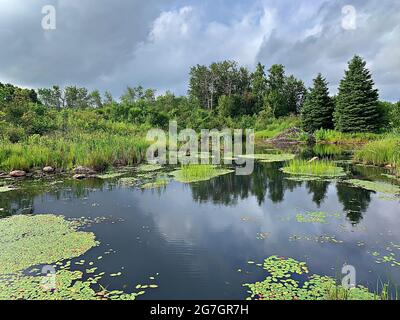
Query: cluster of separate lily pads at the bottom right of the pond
243 256 379 300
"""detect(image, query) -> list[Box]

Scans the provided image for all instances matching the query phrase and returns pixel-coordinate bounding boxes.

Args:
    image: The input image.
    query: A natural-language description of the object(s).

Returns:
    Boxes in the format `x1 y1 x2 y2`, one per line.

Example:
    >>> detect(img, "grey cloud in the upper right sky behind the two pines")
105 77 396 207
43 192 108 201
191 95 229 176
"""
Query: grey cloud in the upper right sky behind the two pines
258 0 400 100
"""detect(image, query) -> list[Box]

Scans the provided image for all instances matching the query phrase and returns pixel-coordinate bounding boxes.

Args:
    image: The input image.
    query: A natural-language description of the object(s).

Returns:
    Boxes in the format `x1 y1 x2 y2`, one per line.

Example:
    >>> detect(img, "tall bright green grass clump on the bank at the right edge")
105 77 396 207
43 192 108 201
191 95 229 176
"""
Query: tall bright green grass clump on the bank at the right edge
354 137 400 175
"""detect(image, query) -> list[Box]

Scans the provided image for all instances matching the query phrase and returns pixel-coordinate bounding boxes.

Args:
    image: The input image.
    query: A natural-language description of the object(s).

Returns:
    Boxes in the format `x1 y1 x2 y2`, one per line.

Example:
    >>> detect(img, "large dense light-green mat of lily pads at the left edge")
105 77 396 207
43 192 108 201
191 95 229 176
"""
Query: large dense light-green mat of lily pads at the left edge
0 215 98 274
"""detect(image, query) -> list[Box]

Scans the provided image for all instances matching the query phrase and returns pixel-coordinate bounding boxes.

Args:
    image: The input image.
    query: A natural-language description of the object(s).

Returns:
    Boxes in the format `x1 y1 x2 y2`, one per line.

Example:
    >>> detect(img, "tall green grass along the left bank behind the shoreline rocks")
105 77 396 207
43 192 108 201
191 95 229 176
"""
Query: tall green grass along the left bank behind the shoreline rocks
0 133 148 171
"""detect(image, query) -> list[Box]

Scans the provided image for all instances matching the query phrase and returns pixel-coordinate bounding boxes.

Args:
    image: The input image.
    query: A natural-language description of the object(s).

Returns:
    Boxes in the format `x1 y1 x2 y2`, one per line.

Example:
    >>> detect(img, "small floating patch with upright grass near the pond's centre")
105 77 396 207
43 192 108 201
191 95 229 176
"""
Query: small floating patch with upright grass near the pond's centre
172 164 234 183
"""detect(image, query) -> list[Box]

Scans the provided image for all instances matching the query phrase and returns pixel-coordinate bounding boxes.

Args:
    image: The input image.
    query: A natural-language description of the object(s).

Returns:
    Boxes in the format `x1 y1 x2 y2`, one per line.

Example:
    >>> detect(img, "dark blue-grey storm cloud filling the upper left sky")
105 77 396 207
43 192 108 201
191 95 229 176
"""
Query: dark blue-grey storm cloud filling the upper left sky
0 0 168 90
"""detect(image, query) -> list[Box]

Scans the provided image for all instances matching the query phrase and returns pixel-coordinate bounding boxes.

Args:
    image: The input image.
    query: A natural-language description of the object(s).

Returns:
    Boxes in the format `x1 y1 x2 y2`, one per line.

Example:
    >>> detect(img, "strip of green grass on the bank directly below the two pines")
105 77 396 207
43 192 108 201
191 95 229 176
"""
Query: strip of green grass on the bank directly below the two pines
314 129 382 144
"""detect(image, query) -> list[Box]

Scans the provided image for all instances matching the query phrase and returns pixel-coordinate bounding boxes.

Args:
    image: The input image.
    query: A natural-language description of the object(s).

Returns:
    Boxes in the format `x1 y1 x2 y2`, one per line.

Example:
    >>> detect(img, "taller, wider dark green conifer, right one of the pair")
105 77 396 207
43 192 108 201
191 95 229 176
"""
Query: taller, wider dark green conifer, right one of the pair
334 56 381 132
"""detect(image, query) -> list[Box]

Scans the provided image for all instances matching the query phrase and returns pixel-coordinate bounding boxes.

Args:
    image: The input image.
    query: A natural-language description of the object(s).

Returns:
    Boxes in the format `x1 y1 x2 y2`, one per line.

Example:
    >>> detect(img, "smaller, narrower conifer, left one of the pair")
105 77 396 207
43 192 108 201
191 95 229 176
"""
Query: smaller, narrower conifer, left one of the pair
301 74 335 133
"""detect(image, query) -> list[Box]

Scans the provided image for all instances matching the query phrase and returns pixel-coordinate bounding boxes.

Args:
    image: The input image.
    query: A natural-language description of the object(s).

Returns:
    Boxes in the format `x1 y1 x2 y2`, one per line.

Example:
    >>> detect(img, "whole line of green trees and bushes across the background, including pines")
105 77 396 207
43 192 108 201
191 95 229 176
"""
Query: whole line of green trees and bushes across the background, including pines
0 56 400 141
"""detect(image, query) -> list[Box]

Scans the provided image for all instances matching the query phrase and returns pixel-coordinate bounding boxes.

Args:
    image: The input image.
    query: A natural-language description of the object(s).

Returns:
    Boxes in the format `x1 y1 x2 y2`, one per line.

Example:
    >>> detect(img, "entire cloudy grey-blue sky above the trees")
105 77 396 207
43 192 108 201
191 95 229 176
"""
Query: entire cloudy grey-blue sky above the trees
0 0 400 101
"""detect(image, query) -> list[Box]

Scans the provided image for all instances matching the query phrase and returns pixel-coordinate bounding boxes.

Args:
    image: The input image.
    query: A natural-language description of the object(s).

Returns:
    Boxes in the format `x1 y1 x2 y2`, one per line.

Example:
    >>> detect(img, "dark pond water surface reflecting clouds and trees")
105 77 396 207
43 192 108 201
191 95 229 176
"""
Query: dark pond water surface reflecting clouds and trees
0 155 400 299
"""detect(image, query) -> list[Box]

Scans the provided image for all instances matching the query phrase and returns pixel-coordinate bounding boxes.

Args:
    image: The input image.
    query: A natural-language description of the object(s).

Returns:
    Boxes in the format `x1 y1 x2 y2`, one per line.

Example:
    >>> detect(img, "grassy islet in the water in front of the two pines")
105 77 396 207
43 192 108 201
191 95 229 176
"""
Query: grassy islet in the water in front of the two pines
283 160 346 177
